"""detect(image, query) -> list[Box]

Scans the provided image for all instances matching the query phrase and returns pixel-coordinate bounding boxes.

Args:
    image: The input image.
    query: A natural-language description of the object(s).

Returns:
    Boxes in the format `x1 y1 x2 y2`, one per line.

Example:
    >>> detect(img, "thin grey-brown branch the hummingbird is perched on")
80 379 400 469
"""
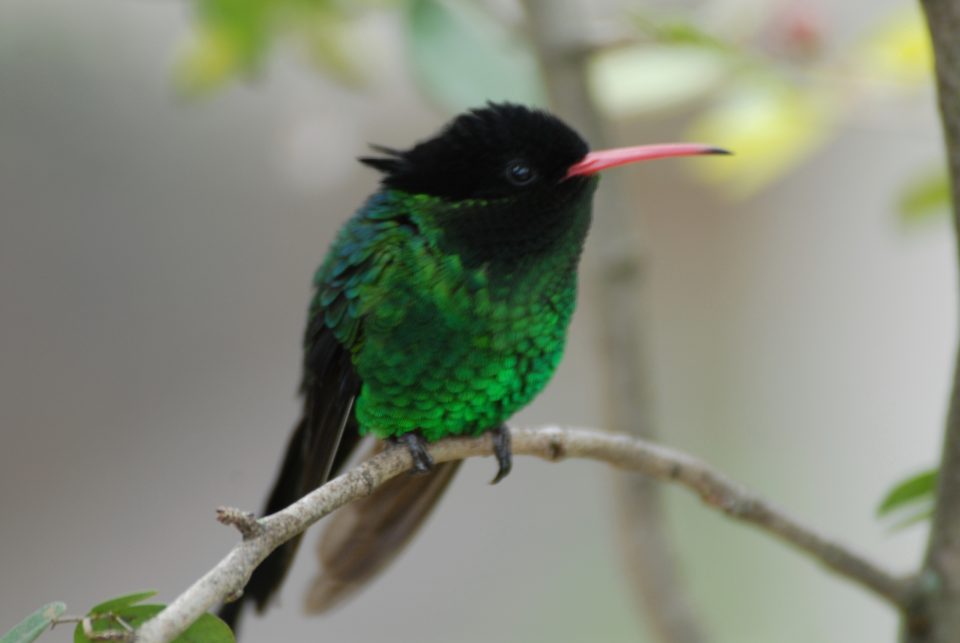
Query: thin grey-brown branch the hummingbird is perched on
136 427 912 643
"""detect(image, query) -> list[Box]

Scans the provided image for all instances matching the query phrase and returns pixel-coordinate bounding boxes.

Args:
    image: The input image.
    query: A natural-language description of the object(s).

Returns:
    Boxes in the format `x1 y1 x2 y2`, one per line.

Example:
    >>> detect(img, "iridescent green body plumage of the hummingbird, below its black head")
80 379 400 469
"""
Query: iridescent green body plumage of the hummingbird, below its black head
310 180 595 441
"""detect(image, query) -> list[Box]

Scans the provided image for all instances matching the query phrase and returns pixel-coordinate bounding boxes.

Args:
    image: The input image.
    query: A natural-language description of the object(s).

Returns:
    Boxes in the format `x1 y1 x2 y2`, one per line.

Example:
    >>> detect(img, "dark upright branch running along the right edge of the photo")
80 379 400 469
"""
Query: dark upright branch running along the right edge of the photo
902 0 960 643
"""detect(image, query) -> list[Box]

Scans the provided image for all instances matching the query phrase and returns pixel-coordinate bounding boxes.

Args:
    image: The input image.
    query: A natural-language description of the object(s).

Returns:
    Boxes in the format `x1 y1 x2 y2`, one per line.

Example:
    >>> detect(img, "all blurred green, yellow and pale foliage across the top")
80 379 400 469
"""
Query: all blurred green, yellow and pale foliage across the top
175 0 939 206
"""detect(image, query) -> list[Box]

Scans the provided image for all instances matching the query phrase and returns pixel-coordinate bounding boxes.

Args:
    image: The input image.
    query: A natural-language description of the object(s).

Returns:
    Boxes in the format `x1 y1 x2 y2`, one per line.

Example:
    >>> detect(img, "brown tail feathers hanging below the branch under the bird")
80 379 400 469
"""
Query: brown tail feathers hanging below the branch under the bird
305 442 460 614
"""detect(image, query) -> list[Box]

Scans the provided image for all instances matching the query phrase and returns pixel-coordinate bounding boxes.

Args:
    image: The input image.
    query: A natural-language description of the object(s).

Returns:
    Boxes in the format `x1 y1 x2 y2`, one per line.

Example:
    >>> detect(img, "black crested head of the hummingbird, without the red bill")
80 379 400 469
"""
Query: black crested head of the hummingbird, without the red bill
360 103 589 200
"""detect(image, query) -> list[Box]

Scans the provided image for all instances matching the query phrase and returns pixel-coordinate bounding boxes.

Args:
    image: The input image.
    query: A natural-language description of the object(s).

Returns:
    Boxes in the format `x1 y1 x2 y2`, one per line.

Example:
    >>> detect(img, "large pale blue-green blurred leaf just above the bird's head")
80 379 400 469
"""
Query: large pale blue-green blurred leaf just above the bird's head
406 0 546 111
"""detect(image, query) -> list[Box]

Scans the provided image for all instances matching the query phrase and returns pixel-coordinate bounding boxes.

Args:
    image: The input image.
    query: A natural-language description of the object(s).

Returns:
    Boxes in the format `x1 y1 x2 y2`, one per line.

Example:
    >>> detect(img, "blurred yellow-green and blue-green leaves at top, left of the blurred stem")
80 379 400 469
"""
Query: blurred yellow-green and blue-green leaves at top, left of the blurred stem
174 0 546 106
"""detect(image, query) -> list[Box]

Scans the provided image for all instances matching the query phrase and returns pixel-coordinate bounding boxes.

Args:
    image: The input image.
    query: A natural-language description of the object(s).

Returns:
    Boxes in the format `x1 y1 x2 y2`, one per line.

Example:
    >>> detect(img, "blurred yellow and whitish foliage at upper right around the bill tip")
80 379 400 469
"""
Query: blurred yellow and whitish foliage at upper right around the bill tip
592 1 932 197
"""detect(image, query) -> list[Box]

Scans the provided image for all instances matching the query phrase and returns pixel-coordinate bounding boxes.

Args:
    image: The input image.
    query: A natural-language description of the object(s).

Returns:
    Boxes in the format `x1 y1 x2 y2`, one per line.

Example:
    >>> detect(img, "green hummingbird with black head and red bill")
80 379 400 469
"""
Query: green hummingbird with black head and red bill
220 103 728 628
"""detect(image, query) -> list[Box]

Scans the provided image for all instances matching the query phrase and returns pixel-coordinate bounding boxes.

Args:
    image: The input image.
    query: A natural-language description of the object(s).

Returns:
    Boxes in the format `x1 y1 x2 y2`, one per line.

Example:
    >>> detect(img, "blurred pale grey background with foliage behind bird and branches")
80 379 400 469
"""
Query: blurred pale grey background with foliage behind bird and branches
0 0 956 643
